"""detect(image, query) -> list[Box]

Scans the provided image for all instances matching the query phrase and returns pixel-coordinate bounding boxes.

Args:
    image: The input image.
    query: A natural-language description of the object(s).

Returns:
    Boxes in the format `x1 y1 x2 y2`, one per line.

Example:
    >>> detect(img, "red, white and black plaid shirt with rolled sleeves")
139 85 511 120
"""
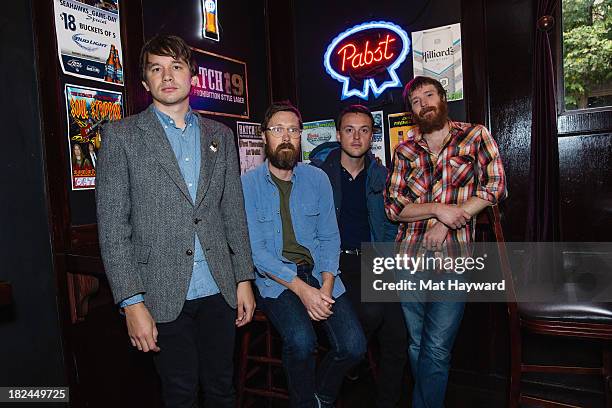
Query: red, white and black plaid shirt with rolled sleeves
385 121 507 252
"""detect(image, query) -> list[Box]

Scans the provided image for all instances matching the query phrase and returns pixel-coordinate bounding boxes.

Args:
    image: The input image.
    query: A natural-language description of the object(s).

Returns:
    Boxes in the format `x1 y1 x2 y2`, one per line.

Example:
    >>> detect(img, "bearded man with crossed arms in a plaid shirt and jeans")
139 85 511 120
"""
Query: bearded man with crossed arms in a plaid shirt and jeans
385 77 507 408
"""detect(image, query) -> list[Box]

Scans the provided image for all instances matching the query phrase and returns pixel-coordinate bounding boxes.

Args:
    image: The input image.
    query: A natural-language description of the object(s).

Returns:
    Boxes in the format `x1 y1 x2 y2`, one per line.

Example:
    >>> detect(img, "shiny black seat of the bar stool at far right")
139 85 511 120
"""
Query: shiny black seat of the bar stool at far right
518 302 612 324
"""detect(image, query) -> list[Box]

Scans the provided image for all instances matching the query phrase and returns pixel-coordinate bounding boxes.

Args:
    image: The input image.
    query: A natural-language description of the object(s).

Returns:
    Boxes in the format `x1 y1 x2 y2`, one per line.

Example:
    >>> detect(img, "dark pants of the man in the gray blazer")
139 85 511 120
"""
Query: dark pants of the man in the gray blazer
154 294 236 408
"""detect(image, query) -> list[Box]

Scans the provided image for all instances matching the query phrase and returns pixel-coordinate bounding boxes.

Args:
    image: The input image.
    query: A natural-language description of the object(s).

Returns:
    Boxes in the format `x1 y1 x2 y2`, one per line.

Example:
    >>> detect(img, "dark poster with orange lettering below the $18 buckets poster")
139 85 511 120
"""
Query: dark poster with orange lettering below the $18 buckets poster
64 84 123 190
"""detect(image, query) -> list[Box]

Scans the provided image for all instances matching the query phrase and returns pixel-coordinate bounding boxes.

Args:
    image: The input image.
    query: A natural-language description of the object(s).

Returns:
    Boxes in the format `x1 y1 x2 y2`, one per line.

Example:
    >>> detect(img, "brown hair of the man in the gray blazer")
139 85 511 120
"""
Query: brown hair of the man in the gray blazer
140 34 198 82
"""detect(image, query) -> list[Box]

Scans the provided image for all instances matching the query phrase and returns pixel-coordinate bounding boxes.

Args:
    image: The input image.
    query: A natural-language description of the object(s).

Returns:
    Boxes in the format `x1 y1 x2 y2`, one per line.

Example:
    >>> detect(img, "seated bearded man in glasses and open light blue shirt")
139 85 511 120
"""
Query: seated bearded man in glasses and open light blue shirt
242 102 365 408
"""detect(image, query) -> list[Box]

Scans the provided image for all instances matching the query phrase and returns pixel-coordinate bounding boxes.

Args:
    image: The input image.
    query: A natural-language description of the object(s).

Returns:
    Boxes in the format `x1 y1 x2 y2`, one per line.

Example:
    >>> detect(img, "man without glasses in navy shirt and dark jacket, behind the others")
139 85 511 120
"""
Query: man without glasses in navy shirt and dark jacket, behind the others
310 105 408 408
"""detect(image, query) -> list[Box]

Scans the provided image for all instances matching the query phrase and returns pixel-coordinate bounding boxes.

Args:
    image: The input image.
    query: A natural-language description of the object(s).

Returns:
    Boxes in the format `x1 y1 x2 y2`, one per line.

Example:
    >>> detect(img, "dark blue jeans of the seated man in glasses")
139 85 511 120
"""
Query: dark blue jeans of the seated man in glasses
257 265 366 408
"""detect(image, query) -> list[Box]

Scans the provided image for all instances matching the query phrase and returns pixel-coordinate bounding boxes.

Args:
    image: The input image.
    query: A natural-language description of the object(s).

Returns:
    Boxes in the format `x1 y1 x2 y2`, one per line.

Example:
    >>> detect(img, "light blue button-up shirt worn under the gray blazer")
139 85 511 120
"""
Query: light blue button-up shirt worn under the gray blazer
120 109 219 307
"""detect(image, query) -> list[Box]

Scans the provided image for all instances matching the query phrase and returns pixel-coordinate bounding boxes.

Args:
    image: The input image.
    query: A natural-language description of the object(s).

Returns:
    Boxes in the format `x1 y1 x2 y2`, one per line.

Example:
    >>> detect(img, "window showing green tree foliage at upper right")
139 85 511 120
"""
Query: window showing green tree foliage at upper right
561 0 612 111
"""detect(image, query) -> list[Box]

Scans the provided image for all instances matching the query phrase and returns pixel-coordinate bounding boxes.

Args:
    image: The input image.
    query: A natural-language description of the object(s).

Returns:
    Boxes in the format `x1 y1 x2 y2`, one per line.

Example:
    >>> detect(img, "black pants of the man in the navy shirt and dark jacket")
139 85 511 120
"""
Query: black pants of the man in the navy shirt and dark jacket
340 254 408 408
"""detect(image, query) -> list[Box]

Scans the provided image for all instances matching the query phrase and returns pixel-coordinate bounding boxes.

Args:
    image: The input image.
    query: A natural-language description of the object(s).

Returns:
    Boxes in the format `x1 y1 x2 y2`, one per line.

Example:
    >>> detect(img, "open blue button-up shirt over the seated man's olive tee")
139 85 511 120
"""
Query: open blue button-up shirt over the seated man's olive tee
242 160 345 298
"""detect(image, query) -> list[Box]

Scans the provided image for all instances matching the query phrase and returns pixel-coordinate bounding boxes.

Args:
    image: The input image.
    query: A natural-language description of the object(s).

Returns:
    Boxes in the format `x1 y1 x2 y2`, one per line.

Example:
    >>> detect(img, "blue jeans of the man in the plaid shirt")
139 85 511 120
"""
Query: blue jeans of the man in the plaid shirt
402 270 465 408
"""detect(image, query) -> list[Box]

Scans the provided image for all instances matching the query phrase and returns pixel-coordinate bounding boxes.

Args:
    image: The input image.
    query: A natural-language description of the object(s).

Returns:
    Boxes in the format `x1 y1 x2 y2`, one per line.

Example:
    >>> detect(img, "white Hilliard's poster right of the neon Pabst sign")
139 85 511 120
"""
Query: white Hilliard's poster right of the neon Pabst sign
412 23 463 101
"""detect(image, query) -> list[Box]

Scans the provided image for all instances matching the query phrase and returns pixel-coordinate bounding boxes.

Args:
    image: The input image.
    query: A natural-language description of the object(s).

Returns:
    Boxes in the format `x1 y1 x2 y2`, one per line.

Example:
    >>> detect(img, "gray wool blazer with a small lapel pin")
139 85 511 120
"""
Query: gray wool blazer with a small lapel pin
96 106 255 323
